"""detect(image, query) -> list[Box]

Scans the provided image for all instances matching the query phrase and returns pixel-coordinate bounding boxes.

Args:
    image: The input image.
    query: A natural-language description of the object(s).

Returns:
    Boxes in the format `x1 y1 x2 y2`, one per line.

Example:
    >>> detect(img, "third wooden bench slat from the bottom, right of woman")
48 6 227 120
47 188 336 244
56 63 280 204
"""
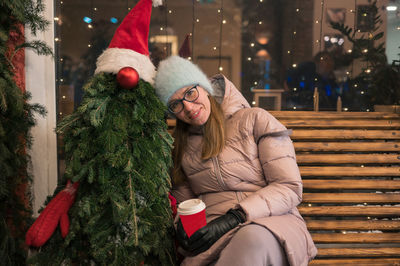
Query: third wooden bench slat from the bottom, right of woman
311 231 400 243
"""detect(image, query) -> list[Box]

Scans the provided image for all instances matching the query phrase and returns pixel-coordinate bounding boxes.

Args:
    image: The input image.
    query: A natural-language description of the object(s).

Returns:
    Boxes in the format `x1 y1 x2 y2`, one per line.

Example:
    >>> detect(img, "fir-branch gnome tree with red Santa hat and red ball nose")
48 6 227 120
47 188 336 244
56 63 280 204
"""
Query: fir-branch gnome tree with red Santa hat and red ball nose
27 0 175 265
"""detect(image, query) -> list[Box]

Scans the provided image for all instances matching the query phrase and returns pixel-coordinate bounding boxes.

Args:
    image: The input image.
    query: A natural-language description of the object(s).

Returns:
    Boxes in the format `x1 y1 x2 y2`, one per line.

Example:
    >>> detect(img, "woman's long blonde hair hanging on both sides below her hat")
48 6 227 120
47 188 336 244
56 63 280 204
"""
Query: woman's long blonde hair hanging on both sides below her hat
172 96 225 185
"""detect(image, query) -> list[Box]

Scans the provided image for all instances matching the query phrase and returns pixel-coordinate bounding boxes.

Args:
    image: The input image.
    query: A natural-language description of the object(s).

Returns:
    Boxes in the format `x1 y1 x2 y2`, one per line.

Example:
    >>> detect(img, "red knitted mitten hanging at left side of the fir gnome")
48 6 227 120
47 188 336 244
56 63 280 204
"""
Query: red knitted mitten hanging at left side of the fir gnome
25 180 79 247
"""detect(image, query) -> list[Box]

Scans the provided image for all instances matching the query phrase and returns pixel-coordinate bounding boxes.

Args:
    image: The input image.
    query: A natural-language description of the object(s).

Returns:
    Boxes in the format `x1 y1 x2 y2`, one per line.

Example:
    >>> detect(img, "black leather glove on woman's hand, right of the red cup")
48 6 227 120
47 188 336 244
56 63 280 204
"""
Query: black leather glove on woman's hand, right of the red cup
188 209 246 255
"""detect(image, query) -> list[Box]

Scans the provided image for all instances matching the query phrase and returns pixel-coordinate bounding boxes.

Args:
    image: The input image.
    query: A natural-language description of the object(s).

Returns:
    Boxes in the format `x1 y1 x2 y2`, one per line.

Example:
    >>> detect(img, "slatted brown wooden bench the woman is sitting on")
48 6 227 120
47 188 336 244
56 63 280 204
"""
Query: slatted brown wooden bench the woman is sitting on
169 111 400 265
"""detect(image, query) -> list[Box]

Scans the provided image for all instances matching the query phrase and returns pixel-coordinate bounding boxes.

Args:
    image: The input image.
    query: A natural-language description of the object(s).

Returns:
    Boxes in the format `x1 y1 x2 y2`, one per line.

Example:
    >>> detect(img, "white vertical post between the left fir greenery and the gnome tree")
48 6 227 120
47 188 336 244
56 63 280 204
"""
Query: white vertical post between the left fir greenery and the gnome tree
25 0 57 215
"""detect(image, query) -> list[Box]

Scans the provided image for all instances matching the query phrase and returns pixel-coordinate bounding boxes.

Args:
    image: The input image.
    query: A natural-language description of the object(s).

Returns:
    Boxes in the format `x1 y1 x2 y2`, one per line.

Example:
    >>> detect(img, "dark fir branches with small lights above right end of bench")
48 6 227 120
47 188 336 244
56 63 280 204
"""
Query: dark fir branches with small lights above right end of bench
331 0 400 106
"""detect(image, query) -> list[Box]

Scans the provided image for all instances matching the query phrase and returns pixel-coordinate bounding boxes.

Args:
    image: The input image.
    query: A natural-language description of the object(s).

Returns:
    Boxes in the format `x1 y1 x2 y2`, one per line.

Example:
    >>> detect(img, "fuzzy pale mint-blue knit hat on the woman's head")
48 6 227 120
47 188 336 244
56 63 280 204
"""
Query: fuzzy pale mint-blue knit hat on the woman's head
154 55 214 104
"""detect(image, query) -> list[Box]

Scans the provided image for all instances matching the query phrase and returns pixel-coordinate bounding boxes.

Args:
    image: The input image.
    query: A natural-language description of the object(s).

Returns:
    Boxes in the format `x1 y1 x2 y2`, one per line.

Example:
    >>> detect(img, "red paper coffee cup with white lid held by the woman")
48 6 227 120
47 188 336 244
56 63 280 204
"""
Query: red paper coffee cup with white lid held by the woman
178 199 207 237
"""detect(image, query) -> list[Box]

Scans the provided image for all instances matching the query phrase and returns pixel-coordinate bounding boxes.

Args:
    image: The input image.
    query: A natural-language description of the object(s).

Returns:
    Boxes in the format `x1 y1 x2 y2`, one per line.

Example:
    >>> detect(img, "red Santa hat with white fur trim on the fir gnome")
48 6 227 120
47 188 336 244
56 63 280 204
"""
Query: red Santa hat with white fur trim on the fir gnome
95 0 162 84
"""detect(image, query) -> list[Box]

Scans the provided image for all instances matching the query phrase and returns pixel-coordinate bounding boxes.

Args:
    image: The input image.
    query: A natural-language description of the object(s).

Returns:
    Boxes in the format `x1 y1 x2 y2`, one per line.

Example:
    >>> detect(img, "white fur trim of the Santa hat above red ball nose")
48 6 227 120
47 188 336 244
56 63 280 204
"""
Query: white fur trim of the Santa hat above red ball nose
94 48 156 84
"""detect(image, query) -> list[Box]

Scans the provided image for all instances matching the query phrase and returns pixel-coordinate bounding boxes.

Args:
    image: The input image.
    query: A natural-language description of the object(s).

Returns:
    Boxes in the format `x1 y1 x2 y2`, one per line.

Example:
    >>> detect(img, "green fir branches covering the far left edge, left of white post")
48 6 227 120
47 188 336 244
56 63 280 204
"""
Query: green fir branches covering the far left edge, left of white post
0 0 51 265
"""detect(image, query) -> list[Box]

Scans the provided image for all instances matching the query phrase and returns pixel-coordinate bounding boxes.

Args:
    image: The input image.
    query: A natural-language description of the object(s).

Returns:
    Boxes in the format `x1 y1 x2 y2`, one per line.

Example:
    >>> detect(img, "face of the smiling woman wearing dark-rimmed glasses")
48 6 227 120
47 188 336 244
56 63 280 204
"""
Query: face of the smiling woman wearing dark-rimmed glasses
168 85 211 126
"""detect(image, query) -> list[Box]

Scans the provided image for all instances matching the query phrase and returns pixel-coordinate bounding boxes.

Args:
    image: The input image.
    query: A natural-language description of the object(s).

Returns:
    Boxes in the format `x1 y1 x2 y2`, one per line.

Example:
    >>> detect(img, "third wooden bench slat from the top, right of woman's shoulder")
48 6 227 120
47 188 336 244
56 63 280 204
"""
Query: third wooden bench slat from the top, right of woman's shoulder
291 129 400 141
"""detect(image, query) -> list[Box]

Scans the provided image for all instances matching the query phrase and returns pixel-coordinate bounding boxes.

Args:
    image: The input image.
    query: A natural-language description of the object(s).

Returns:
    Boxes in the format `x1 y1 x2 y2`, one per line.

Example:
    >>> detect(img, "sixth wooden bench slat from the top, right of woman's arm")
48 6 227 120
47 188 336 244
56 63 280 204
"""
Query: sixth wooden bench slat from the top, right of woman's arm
300 166 400 177
